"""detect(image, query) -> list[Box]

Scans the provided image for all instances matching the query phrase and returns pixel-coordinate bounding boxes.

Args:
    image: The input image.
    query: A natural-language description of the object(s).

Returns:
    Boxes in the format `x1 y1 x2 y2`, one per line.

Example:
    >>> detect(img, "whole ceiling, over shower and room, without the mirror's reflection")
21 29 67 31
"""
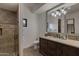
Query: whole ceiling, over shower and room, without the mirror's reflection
0 3 61 13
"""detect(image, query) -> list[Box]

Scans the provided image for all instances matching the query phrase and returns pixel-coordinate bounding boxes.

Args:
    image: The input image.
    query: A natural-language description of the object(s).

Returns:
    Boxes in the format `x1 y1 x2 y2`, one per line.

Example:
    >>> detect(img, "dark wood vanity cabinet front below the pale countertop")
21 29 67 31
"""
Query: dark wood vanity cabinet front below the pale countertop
39 38 79 56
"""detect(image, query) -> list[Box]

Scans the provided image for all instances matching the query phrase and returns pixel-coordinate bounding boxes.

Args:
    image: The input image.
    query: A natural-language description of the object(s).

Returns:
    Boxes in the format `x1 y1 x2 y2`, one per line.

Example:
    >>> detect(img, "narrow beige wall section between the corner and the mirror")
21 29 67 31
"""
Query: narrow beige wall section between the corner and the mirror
37 12 46 37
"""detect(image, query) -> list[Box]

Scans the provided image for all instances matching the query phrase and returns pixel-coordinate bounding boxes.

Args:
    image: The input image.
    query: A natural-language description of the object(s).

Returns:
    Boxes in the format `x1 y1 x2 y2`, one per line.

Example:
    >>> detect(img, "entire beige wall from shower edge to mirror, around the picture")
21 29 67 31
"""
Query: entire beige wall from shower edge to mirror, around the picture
19 4 46 51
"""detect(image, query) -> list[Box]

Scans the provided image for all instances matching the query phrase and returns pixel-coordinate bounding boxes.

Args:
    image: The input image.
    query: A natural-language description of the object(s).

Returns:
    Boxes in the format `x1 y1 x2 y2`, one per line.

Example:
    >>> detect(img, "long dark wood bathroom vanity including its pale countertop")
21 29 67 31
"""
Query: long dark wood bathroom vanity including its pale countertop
39 36 79 56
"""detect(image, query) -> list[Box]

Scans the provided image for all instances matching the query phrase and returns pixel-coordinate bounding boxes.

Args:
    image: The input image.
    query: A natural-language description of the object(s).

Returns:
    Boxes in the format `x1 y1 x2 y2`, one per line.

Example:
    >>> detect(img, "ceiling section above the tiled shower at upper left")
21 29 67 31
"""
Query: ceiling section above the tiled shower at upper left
0 3 18 12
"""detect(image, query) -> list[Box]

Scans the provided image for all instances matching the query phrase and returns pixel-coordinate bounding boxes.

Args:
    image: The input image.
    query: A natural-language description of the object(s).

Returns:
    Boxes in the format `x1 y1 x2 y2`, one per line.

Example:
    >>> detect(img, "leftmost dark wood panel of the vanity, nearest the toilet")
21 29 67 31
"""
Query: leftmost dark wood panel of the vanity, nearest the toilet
39 38 47 55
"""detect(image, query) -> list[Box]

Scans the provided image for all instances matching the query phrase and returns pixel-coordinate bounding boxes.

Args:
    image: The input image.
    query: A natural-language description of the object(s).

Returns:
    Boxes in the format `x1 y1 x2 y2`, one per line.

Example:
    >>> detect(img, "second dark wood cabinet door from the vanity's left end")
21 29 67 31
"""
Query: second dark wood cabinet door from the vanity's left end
47 41 57 56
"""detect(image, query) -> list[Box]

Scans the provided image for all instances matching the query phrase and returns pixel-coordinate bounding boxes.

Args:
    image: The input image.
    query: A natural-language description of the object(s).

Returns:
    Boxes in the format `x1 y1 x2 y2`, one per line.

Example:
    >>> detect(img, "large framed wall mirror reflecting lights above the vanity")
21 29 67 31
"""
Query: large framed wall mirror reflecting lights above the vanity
46 3 79 40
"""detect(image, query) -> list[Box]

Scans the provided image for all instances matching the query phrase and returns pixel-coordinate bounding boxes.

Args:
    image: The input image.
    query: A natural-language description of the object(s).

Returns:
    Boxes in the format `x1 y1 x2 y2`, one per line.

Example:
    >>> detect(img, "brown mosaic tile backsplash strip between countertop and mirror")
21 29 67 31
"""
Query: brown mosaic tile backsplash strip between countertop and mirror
45 32 79 41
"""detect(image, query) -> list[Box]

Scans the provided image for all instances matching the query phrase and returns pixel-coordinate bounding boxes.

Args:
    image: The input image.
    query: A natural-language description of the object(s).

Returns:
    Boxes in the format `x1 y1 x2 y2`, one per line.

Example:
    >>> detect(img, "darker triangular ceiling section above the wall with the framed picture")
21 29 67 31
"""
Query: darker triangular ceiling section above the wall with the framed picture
25 3 45 12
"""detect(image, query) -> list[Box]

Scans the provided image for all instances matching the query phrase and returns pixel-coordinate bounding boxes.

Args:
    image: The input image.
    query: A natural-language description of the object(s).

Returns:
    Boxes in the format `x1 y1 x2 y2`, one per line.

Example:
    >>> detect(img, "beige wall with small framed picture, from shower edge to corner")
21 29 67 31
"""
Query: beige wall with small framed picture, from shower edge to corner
19 4 37 51
